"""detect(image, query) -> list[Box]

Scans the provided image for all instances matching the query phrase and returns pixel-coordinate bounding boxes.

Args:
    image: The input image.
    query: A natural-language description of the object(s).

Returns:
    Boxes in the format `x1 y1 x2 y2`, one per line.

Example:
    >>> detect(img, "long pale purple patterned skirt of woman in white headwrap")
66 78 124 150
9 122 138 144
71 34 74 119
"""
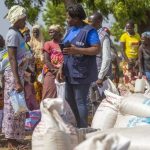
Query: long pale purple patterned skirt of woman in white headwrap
2 69 26 140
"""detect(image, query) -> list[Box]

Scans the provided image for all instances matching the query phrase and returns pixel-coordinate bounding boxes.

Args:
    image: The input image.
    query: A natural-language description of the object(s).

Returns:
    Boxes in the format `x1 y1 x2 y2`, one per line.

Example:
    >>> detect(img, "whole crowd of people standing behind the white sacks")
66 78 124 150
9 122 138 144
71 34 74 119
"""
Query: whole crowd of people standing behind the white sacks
0 4 150 149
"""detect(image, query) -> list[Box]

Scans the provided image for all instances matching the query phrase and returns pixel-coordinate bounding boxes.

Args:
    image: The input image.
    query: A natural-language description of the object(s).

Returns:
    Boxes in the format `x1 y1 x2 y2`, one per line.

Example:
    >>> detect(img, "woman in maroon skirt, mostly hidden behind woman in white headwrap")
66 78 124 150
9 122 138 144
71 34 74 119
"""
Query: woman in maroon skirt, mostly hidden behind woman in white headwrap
21 27 38 110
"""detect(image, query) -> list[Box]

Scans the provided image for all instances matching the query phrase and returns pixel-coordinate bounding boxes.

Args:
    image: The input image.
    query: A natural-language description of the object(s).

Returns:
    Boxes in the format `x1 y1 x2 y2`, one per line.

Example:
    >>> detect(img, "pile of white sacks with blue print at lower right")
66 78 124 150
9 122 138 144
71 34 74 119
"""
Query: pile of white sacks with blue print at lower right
79 79 150 150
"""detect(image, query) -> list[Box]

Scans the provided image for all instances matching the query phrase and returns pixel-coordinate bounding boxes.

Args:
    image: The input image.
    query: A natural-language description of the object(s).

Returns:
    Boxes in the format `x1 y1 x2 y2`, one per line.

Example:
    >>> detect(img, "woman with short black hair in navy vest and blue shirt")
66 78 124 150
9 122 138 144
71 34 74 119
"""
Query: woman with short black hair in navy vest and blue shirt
57 4 100 127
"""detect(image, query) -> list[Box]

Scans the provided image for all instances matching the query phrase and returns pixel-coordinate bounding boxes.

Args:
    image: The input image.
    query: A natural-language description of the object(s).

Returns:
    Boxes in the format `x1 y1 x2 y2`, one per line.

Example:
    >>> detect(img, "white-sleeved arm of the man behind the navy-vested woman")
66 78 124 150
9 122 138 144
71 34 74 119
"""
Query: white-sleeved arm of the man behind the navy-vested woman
98 38 111 80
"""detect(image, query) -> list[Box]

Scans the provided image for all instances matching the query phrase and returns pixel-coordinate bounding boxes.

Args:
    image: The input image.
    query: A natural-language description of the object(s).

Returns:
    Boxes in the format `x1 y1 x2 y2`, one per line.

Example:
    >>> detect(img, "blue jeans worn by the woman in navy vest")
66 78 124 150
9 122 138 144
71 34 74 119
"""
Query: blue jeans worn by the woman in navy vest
65 82 90 128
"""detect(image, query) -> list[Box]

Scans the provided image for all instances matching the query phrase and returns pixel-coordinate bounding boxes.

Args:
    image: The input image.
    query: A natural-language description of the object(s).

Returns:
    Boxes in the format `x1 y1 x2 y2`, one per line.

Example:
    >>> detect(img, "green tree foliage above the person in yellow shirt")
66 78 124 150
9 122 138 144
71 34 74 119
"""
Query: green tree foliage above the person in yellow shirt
95 0 150 40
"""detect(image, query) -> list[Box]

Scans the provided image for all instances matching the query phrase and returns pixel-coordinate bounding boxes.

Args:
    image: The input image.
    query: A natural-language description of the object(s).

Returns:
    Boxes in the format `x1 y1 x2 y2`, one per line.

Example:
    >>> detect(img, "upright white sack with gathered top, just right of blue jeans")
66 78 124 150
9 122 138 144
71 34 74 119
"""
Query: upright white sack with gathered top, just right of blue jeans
91 90 121 130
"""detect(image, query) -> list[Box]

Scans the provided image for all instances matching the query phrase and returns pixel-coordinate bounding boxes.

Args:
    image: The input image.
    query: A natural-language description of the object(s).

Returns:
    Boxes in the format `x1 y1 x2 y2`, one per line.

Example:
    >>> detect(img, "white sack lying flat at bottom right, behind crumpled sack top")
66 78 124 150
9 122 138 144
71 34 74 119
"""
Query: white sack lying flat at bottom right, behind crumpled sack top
86 126 150 150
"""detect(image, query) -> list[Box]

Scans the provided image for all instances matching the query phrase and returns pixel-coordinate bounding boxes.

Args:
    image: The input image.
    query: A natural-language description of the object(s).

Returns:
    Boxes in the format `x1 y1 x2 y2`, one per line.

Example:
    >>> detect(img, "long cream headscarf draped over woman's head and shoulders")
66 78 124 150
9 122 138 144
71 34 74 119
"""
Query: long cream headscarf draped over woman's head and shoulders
29 25 44 60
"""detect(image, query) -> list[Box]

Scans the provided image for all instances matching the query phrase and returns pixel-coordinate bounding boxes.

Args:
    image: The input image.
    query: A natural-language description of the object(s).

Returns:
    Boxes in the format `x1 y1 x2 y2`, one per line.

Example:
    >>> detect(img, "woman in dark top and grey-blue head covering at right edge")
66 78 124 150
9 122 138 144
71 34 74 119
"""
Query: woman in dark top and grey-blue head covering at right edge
139 32 150 84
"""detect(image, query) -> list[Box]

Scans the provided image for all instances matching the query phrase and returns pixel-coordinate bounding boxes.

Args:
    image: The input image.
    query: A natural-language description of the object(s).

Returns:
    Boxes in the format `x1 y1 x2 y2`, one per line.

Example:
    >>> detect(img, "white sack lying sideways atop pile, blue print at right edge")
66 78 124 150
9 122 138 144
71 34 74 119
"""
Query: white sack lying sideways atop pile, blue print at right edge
120 94 150 117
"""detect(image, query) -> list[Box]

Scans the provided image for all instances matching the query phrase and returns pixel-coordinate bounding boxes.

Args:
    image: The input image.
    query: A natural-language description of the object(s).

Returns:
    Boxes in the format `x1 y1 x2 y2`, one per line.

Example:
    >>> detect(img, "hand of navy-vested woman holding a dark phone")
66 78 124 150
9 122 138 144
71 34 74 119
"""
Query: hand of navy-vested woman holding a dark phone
63 45 79 55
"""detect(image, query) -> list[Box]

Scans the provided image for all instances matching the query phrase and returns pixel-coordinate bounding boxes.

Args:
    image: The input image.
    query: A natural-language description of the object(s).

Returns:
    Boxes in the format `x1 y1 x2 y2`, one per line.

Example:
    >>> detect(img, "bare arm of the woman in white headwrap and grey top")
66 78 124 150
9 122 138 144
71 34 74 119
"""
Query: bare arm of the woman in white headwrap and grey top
8 47 23 92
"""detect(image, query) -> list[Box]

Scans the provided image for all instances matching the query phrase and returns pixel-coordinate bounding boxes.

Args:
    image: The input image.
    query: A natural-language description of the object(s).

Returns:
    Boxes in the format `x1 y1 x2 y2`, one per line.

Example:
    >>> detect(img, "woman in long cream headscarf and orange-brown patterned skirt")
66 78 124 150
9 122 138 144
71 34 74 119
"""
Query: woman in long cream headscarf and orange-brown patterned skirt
29 25 44 103
